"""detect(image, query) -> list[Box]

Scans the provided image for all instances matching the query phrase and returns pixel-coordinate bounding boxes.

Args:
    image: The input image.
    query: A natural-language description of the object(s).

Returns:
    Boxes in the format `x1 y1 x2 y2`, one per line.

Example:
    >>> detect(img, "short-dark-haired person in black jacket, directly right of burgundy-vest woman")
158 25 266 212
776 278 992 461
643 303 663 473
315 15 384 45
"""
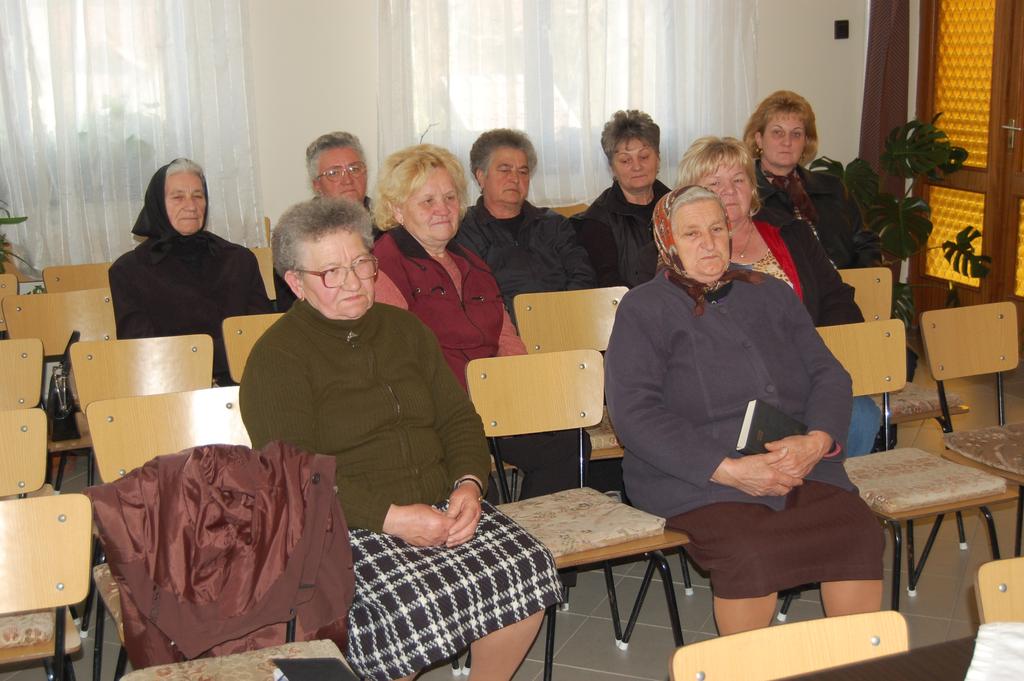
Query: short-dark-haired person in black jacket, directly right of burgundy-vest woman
455 128 597 322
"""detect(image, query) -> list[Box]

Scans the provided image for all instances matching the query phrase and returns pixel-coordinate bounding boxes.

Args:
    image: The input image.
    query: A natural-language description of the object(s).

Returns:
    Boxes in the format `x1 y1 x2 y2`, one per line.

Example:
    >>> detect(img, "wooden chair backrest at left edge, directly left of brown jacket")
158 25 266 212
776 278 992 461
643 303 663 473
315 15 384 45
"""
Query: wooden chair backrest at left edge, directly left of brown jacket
0 495 92 614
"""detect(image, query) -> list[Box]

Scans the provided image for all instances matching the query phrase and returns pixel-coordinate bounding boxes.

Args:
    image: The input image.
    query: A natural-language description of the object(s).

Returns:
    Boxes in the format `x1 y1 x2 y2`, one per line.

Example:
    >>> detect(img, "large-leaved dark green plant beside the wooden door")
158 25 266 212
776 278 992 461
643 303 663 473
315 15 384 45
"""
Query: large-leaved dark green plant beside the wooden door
810 114 992 328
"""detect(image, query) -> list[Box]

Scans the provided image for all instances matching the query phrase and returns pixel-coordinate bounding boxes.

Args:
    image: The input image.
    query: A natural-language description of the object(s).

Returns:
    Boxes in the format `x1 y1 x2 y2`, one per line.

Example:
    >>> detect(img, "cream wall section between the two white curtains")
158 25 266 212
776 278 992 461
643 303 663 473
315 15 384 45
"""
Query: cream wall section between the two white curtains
249 0 378 228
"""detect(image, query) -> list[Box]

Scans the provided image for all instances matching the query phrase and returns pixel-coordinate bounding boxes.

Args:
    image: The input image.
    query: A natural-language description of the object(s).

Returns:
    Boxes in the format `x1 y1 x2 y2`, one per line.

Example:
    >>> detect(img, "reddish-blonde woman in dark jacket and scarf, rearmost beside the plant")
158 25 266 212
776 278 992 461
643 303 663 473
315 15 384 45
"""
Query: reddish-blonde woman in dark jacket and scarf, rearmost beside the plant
743 90 882 269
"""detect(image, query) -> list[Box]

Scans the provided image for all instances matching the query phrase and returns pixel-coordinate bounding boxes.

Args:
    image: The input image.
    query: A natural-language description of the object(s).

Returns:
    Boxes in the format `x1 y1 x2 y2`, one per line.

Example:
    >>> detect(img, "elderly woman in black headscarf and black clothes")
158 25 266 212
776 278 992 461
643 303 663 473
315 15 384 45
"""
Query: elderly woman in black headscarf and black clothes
110 159 272 385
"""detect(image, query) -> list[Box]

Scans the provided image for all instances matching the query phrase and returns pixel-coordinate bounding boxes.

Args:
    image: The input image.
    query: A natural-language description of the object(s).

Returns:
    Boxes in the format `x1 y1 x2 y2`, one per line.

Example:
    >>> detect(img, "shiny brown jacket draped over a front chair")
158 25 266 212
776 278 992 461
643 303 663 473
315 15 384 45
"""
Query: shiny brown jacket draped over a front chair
85 442 354 669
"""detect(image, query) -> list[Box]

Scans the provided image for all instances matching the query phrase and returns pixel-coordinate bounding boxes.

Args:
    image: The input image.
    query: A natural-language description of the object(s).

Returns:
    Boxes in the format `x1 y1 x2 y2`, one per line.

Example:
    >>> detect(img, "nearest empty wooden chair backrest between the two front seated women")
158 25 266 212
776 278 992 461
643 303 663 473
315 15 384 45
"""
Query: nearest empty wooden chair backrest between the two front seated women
466 350 604 437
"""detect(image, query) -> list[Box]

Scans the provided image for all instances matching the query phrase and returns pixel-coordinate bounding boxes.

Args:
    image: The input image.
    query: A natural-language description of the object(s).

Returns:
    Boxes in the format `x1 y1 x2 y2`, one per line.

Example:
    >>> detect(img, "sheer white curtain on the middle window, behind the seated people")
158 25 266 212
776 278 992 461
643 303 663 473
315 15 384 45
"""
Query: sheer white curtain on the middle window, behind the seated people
379 0 757 206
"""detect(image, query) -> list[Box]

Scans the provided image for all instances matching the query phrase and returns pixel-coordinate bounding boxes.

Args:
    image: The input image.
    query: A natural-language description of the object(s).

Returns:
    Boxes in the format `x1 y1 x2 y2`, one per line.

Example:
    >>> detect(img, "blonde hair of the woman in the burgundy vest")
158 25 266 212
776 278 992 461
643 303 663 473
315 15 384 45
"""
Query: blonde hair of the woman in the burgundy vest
374 144 466 231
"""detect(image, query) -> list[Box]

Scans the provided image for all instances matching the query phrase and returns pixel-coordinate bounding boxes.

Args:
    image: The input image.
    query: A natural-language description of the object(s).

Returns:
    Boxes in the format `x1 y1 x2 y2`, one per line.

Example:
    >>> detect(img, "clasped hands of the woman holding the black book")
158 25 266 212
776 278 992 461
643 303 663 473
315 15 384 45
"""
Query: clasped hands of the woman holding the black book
711 430 833 497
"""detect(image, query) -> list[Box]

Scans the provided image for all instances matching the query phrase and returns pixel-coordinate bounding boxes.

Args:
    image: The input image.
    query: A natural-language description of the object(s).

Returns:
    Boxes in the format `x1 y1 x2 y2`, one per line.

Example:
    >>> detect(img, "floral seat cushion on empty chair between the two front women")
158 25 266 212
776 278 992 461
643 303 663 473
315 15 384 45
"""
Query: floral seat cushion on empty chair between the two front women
498 487 665 558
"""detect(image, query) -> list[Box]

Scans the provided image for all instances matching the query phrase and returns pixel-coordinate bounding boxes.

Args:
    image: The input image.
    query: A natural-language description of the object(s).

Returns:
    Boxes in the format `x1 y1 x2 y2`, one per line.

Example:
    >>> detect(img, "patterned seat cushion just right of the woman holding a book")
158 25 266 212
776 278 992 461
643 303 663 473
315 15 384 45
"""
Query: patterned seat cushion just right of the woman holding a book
845 448 1007 514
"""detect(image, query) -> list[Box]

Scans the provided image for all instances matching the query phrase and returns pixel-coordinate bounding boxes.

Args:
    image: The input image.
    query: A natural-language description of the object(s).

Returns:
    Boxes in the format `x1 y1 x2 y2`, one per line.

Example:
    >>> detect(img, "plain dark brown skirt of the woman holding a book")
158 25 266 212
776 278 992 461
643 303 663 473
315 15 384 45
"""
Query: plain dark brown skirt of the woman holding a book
667 480 885 598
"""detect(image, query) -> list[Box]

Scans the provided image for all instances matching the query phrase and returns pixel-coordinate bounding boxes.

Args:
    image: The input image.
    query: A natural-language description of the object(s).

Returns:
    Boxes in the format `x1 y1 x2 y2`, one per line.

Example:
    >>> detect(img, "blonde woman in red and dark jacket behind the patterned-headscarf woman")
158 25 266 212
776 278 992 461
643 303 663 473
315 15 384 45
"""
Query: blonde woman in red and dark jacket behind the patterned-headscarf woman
679 137 882 456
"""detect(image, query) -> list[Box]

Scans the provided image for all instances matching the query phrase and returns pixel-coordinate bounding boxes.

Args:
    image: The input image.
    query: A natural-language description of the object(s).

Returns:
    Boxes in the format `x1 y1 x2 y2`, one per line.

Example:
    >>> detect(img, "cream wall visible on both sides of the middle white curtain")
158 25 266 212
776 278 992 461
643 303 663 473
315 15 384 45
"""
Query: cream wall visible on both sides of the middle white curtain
250 0 888 221
